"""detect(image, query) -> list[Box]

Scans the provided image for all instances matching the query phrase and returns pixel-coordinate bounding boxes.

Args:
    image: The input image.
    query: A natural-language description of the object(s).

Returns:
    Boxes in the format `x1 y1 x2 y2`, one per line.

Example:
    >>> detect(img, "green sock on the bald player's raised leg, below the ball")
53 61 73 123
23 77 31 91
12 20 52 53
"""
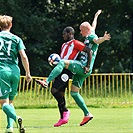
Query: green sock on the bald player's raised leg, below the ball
46 60 65 84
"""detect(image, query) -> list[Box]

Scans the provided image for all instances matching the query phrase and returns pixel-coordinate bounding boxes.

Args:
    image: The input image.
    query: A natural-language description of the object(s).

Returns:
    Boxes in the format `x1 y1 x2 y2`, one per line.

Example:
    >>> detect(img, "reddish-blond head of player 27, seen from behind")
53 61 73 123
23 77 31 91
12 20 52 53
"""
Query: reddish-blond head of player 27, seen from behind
0 15 12 30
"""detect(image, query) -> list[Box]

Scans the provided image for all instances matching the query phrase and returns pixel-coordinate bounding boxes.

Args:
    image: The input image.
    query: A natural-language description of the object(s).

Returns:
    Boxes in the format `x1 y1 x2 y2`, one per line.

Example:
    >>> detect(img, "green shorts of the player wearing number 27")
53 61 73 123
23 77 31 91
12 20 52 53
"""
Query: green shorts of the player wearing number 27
0 71 20 100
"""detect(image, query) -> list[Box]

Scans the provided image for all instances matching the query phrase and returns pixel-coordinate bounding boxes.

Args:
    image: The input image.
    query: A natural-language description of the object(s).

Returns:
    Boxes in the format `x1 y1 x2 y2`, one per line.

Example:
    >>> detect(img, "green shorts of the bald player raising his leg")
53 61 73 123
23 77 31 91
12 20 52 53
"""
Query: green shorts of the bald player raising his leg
68 60 92 88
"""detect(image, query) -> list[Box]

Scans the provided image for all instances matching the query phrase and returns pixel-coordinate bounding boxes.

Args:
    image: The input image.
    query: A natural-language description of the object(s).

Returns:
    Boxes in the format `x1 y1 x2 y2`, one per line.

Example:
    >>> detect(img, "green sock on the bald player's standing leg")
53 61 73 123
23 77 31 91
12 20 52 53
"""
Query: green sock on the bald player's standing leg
70 92 89 116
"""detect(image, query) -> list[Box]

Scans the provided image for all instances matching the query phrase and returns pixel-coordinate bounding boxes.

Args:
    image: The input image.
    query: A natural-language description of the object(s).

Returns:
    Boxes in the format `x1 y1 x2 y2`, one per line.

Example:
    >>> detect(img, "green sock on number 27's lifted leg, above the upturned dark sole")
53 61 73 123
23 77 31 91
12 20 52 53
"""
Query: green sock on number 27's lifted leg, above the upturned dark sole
2 103 17 122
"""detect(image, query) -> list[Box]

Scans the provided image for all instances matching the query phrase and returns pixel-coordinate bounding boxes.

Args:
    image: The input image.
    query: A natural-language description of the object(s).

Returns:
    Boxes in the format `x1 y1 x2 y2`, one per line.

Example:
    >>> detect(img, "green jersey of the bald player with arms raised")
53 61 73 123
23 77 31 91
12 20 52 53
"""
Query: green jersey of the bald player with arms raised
79 32 99 70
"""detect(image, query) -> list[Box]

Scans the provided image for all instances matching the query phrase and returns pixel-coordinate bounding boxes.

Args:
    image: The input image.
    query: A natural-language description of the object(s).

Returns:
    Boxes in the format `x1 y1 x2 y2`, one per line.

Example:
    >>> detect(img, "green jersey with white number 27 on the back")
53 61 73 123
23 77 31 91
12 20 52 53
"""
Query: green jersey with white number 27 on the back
0 31 25 71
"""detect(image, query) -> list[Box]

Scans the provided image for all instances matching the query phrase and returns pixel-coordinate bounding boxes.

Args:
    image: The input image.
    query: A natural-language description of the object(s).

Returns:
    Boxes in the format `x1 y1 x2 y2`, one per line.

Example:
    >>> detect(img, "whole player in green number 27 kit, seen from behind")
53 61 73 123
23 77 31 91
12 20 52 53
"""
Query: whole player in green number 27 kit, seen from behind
0 15 32 133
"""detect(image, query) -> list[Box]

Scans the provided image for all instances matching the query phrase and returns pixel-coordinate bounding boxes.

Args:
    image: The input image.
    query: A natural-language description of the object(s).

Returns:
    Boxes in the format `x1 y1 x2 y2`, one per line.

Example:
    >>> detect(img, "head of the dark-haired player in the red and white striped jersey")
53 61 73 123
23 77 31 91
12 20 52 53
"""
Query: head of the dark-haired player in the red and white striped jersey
63 26 75 41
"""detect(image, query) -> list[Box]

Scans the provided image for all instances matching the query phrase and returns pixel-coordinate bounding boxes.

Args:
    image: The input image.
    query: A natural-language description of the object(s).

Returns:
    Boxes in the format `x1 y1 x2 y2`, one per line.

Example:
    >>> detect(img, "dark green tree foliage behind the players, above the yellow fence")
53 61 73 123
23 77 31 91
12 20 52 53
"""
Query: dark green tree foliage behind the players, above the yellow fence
0 0 133 76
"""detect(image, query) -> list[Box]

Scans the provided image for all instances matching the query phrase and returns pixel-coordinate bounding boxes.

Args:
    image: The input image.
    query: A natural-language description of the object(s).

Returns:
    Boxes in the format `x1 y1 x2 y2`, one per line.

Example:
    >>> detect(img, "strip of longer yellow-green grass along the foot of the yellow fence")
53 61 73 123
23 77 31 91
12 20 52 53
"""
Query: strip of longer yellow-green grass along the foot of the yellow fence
14 91 133 108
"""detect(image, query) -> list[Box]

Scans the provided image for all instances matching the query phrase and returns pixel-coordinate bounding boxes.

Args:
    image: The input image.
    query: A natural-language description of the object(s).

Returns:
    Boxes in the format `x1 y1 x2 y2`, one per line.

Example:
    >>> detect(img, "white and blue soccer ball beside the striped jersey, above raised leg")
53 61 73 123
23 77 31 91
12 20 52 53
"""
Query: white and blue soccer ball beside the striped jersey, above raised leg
48 53 61 66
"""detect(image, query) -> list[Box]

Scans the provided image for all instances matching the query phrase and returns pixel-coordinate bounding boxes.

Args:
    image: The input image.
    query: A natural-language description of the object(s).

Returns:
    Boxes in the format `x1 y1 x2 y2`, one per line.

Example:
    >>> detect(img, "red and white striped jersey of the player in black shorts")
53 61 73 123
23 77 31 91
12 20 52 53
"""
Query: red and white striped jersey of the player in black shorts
60 39 85 60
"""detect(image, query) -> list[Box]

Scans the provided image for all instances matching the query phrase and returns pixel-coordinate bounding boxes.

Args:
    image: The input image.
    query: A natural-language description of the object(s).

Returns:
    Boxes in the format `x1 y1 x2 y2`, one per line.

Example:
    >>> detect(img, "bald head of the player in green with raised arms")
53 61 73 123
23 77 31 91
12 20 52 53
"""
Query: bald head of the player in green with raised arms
79 22 91 37
